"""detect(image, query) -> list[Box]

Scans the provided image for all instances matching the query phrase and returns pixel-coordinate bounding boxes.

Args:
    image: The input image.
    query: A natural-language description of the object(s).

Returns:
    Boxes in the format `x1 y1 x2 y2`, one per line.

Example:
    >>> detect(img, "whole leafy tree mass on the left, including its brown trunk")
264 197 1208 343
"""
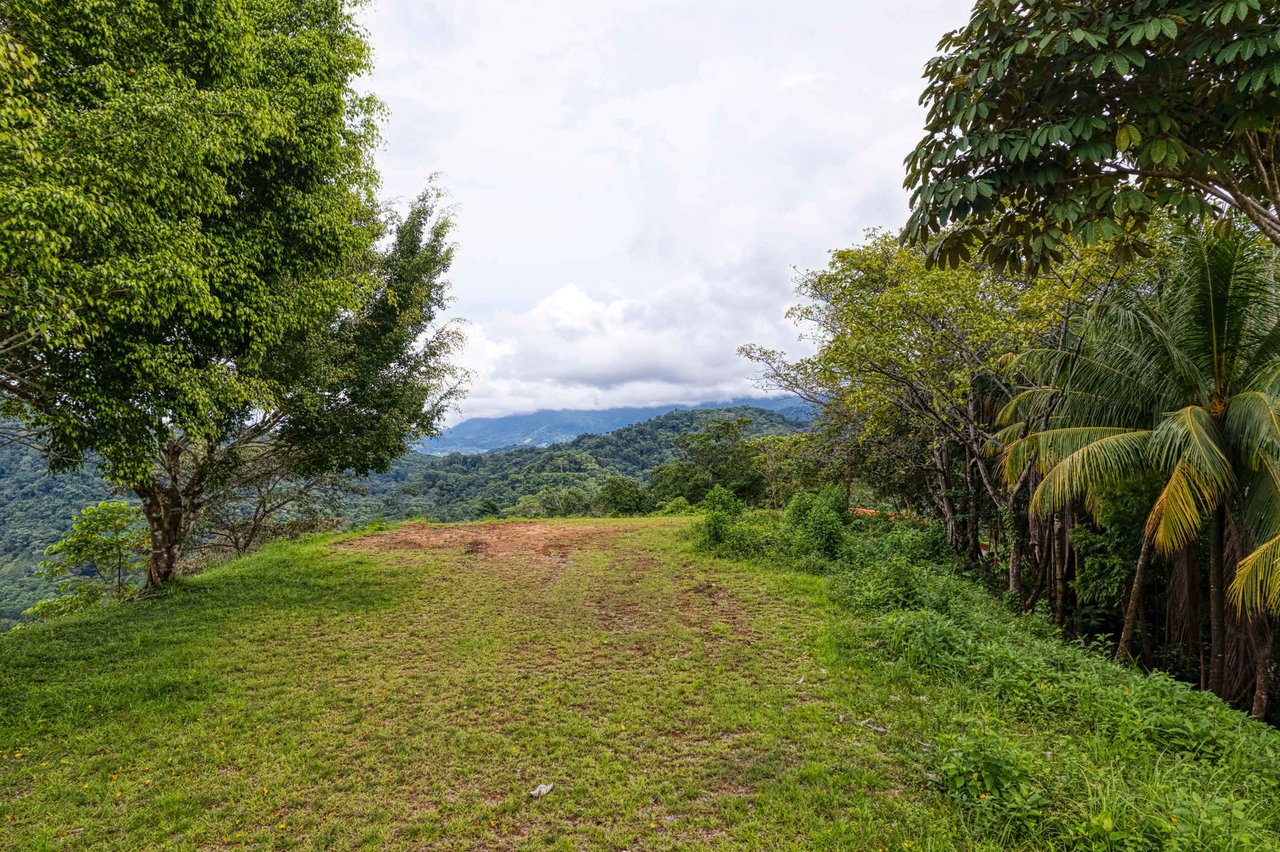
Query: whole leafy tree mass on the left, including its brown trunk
0 0 476 586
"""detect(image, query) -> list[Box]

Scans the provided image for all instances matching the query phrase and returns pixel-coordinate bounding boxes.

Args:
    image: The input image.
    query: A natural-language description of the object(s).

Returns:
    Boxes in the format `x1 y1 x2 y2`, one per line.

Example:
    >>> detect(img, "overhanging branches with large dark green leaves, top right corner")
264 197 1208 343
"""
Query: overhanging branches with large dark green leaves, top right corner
906 0 1280 267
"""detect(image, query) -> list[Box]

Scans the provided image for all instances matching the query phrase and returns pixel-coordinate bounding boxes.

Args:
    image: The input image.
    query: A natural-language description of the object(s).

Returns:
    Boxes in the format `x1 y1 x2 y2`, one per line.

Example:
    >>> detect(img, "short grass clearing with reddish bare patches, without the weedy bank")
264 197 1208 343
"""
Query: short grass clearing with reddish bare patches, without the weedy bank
0 519 986 849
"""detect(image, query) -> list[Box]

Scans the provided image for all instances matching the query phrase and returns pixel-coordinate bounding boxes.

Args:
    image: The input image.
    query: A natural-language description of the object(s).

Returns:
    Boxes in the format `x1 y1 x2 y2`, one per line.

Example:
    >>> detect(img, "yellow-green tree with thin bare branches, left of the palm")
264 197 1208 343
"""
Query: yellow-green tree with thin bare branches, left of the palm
741 233 1121 578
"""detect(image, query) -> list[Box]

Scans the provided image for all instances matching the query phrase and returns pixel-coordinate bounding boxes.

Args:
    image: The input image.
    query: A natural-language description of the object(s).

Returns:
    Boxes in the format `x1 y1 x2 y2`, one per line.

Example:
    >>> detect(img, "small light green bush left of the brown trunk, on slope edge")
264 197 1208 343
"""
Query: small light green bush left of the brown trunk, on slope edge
26 501 150 619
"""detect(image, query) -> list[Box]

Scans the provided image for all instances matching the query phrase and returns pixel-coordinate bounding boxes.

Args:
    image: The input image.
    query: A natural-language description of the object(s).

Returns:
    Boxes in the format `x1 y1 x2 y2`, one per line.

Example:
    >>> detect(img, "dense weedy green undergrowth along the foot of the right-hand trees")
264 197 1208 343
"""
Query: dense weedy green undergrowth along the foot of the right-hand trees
699 493 1280 852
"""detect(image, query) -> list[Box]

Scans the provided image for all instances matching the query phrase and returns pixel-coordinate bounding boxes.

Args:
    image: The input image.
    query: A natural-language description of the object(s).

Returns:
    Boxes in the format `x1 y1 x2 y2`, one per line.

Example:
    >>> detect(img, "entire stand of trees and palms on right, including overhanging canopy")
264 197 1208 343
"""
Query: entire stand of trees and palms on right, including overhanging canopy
745 0 1280 718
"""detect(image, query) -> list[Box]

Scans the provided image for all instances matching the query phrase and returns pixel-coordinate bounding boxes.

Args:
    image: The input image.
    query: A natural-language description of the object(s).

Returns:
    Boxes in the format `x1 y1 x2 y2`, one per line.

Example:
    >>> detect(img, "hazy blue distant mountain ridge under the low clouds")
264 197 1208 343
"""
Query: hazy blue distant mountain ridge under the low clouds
417 397 810 455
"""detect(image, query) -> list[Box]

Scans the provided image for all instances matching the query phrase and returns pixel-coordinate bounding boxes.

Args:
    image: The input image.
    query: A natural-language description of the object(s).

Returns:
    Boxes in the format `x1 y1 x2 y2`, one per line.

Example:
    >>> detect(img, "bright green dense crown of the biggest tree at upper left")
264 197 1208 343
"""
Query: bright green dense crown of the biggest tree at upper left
0 0 379 470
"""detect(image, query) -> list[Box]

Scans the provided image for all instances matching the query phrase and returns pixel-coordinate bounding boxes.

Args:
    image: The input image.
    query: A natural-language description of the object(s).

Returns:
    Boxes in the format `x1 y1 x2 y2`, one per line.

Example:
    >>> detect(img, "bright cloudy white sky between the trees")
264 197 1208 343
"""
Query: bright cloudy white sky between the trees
361 0 972 421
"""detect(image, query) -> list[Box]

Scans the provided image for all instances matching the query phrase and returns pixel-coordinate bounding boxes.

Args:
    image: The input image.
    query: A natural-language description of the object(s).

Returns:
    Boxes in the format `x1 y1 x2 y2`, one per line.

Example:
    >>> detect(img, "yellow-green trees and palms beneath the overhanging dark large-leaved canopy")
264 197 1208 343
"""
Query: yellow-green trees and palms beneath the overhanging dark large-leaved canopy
746 224 1280 718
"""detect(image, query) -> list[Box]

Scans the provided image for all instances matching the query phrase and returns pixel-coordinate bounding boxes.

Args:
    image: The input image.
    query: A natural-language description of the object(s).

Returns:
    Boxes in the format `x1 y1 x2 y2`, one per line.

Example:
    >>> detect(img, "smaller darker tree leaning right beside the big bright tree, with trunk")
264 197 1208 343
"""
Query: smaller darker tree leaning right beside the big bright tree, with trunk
128 187 465 586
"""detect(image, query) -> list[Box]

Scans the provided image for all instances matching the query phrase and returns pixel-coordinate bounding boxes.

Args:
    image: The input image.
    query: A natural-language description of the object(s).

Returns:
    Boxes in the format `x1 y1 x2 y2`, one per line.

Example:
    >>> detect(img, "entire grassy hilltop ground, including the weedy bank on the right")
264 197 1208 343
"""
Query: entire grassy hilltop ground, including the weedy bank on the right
0 519 1280 852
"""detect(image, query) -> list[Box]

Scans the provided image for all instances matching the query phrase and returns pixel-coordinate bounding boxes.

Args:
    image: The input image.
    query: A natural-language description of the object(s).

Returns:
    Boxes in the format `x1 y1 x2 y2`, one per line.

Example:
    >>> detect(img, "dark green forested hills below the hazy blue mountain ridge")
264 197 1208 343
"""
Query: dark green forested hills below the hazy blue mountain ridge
0 407 808 628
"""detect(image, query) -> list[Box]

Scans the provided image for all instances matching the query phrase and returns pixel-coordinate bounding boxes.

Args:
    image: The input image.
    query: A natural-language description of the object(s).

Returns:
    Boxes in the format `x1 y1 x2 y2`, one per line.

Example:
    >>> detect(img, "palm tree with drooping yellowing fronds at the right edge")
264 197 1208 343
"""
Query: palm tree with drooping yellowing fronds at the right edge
1001 228 1280 711
